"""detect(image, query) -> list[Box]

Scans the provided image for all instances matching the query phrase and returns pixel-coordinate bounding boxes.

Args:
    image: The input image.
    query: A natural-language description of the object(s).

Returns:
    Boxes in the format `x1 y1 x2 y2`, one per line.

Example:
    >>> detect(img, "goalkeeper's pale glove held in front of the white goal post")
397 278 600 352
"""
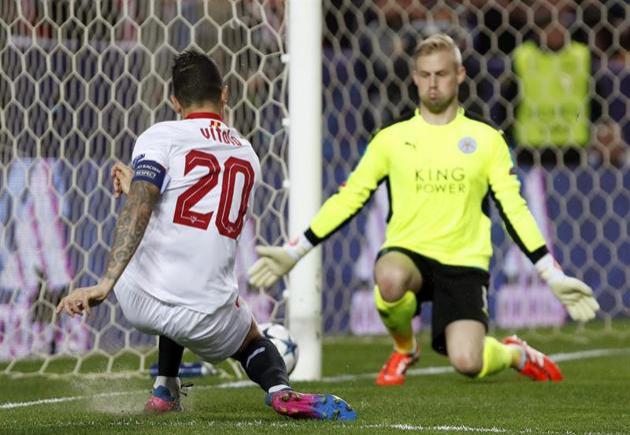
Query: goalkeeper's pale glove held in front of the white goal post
247 234 313 288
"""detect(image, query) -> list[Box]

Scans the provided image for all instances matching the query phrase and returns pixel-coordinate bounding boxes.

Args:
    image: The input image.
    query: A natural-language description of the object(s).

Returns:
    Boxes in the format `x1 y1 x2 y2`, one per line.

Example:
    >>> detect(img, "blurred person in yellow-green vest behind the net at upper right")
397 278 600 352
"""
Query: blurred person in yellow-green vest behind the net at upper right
513 11 591 163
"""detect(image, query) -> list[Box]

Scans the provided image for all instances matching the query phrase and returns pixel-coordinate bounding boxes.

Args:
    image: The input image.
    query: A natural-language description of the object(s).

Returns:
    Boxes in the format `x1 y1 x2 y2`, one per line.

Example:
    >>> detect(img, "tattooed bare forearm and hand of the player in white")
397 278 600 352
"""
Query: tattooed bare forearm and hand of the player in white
56 181 160 316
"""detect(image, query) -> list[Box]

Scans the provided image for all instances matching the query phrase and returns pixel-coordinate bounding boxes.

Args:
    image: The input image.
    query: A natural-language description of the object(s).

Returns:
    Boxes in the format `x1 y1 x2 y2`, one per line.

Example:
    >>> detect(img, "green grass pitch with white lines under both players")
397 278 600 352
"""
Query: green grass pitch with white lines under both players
0 325 630 434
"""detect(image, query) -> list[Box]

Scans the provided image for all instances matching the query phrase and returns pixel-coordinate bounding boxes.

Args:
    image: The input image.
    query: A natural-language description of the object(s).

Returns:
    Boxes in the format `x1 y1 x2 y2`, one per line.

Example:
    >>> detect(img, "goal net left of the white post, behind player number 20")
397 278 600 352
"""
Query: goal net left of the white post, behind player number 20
0 0 287 373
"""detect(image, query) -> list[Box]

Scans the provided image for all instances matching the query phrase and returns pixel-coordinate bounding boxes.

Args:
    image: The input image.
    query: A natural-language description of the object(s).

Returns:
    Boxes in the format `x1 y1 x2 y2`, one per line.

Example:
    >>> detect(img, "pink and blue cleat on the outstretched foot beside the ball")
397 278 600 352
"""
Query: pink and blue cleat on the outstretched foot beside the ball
265 390 357 421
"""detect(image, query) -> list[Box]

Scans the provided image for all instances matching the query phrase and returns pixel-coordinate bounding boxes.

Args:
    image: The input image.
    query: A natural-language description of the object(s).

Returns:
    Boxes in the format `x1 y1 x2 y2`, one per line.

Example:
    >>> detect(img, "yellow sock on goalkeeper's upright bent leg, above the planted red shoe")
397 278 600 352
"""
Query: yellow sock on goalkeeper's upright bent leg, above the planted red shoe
374 286 418 354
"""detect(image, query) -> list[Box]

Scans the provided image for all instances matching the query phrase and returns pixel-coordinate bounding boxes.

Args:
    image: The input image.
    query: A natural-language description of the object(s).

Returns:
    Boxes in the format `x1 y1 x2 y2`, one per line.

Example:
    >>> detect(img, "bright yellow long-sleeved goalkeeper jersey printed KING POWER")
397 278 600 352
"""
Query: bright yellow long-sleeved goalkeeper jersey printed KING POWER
305 108 547 270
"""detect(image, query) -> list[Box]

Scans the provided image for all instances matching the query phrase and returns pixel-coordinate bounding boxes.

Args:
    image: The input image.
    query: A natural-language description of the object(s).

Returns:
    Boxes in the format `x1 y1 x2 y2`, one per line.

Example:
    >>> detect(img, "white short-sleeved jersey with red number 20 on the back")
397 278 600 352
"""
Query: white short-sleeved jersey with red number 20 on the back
121 113 260 314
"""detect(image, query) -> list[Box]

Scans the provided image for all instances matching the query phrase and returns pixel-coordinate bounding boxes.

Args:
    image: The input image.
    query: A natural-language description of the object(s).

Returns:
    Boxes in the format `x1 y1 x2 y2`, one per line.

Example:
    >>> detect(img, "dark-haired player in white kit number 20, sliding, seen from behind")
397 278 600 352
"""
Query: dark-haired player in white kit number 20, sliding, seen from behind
57 50 356 420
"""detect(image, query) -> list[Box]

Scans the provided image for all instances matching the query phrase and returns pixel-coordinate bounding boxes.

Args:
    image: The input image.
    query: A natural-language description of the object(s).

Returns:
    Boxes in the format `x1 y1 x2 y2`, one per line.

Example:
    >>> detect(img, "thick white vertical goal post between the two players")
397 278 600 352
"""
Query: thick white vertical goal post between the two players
287 0 322 380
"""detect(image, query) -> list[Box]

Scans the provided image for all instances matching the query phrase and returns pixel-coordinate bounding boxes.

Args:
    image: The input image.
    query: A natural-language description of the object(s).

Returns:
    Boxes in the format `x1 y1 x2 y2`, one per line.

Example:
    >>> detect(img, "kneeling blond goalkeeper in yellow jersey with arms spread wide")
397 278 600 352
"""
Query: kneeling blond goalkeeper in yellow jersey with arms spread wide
250 34 599 385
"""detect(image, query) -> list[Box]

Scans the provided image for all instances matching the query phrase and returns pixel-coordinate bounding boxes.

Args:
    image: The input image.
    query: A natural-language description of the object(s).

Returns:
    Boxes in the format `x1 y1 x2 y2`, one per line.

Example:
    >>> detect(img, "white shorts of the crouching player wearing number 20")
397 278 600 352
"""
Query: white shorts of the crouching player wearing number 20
114 278 253 363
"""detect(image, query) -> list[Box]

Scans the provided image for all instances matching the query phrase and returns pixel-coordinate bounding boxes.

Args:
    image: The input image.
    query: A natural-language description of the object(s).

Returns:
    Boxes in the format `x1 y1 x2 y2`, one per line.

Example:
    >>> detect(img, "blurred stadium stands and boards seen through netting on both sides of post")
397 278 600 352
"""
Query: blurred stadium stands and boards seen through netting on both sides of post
0 0 630 372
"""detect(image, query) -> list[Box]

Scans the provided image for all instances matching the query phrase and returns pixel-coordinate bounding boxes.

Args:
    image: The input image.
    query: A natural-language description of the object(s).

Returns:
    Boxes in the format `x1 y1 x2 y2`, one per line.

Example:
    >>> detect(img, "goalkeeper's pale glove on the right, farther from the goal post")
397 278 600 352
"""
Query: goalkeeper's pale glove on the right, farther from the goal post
535 254 599 322
